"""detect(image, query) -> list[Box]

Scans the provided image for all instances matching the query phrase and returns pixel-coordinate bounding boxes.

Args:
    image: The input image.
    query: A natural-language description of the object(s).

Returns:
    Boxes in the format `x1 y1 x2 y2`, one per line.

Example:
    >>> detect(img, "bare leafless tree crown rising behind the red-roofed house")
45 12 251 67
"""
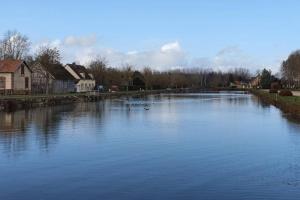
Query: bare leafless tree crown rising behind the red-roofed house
0 31 30 60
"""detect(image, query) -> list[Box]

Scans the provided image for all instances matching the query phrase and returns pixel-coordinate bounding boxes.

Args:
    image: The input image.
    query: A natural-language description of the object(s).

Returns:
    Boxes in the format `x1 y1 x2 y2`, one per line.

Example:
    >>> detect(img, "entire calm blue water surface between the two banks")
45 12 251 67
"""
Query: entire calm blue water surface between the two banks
0 93 300 200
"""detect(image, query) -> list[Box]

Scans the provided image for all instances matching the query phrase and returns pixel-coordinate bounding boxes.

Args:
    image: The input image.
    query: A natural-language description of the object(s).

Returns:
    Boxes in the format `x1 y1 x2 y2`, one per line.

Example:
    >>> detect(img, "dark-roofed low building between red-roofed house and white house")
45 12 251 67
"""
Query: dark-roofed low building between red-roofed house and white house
32 63 76 93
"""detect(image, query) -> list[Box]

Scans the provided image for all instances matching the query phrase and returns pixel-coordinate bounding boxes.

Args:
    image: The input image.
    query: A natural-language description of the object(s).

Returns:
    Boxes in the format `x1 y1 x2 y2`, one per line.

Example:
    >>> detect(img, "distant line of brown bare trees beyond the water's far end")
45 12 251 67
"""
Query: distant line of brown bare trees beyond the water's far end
89 57 251 89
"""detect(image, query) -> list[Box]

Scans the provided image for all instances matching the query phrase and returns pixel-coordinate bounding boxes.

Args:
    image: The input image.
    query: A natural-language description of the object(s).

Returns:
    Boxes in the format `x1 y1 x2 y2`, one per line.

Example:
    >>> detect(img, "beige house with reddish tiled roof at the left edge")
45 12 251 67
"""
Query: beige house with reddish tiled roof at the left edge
0 60 32 94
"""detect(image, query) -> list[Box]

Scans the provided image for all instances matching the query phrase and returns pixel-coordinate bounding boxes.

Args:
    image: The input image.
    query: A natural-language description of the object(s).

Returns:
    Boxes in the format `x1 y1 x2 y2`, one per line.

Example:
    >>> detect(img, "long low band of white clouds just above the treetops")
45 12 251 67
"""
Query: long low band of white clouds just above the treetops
35 35 274 72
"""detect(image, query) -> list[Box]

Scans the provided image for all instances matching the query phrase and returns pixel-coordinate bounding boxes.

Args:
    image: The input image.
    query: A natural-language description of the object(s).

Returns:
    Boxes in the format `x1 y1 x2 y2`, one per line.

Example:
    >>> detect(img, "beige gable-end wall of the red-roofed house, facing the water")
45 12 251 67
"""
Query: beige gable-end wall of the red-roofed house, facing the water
13 64 31 91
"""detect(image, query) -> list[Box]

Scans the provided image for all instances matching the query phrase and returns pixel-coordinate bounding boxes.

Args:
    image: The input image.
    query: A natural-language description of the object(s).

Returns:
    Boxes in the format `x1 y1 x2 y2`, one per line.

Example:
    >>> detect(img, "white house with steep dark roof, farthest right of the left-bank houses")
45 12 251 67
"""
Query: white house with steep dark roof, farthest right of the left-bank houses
65 63 96 92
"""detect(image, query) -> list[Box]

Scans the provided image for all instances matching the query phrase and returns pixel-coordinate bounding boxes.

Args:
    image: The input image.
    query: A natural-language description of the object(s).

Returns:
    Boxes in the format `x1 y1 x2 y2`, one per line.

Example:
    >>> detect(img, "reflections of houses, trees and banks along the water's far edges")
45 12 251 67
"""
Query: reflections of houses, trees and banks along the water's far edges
0 93 300 155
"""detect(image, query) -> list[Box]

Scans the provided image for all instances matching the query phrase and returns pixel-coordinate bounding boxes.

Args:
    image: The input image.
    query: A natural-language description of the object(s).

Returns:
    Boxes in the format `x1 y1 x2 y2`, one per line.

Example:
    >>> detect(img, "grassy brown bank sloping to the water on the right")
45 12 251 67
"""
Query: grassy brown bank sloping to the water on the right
251 90 300 115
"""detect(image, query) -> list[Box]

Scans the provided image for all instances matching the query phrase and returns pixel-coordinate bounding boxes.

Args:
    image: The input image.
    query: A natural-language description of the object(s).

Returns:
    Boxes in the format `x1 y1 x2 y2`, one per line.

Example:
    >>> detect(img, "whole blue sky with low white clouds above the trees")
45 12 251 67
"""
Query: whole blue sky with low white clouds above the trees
0 0 300 71
